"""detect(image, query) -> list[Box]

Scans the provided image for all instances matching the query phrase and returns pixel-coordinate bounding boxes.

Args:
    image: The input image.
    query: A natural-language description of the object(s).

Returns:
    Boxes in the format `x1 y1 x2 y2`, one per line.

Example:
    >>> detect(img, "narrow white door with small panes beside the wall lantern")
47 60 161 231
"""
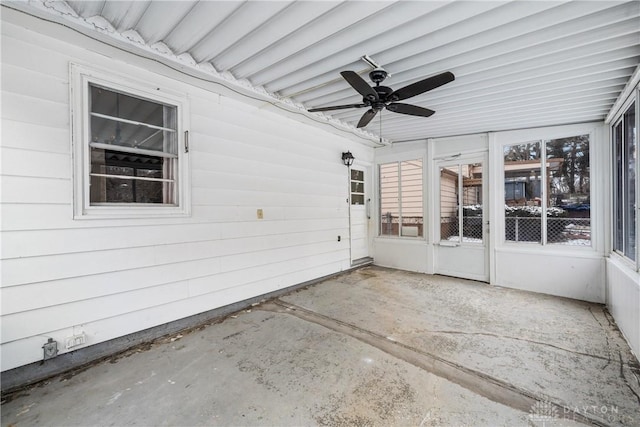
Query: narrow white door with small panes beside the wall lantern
349 167 371 264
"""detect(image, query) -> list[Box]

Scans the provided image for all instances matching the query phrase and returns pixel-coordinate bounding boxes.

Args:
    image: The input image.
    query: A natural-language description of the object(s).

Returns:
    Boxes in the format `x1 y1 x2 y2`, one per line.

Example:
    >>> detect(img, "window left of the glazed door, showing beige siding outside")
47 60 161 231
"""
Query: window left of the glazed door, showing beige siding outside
380 159 424 237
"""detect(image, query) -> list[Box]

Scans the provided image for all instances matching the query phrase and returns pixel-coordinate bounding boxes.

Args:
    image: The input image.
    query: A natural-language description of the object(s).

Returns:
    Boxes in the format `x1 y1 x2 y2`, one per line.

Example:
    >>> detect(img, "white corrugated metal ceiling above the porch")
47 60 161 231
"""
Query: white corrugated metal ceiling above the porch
5 0 640 142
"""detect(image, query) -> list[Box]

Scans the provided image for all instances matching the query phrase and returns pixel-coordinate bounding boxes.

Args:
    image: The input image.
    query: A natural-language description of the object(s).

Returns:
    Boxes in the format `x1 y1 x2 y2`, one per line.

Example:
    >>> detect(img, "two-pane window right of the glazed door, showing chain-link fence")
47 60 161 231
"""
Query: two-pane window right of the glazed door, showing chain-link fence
503 135 591 246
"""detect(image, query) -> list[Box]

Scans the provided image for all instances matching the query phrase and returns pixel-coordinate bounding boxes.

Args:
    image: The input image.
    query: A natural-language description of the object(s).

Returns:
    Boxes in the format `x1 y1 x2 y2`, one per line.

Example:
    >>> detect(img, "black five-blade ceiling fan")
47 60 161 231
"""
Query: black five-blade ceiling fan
309 68 455 128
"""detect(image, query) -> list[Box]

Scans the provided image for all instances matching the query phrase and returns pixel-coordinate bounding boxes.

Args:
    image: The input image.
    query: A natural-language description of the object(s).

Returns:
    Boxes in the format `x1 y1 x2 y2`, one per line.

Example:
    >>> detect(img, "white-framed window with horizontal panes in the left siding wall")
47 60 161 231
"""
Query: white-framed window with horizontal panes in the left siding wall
72 66 188 217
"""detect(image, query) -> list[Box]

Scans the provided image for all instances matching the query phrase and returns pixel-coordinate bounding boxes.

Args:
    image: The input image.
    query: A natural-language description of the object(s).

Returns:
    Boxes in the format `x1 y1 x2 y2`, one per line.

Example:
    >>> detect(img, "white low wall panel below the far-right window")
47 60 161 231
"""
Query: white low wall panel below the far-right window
607 254 640 357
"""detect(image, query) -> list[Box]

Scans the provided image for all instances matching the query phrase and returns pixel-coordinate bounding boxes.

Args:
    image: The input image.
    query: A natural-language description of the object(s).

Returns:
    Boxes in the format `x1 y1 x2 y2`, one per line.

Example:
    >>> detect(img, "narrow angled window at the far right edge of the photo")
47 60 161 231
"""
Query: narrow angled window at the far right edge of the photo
613 103 637 261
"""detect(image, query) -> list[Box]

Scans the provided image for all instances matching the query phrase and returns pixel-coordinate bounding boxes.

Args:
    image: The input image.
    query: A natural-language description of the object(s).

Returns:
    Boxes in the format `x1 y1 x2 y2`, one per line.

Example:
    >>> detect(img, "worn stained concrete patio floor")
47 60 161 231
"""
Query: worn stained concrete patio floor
2 267 640 426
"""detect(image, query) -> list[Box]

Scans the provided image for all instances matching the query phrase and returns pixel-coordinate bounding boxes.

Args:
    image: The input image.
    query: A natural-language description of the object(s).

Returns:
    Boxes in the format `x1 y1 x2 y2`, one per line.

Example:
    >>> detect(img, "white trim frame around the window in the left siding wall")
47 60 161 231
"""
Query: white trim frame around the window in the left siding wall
69 63 191 219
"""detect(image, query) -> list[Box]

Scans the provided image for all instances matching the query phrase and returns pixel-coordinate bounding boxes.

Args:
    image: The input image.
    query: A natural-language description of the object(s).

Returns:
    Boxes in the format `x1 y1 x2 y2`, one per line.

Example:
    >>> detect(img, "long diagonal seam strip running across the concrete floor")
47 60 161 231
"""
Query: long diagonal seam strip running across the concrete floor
257 299 609 426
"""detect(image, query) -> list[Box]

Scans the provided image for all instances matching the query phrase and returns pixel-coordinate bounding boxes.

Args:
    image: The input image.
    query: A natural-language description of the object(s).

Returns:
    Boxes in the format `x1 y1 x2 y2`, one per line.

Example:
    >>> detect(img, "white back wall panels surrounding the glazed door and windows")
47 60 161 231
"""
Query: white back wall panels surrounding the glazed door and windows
374 123 609 303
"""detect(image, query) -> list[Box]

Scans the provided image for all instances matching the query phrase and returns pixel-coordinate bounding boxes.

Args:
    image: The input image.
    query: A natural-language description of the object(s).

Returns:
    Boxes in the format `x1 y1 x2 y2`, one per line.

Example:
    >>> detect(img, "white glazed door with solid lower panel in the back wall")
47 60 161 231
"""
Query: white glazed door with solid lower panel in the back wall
434 155 489 282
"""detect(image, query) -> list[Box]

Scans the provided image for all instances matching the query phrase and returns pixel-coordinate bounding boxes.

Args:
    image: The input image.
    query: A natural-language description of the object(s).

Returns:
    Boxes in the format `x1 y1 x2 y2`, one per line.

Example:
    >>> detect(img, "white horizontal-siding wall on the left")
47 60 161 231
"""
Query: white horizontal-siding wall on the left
1 8 373 371
